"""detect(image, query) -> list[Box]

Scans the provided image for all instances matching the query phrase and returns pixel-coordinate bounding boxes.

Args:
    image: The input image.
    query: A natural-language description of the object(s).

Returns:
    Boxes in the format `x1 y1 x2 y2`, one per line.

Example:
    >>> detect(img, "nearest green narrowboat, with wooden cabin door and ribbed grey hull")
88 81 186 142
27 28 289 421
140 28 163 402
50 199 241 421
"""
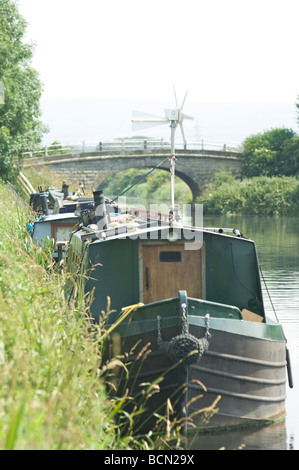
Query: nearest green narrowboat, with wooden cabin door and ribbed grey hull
69 196 292 430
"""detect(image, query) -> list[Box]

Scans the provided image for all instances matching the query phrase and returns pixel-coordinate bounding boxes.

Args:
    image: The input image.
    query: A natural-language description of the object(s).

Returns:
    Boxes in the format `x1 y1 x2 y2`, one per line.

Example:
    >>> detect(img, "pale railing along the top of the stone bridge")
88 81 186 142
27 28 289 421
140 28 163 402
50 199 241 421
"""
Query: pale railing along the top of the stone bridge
22 139 241 158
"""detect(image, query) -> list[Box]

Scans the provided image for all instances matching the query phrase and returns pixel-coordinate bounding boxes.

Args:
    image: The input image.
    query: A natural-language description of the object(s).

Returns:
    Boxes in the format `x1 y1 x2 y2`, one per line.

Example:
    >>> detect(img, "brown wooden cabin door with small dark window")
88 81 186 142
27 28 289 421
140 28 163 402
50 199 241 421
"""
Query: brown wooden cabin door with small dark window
140 242 204 304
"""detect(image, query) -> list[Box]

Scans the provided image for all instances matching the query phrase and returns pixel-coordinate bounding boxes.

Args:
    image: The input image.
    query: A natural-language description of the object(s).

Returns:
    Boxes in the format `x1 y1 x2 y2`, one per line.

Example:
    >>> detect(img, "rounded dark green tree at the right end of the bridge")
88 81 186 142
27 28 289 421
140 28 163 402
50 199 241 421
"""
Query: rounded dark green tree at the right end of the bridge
243 128 298 177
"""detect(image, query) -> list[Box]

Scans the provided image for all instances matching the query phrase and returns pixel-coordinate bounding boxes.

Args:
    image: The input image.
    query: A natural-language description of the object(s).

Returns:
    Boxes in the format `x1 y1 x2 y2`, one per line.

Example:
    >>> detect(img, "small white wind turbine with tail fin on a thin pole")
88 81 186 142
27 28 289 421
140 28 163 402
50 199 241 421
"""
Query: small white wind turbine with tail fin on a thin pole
132 89 194 223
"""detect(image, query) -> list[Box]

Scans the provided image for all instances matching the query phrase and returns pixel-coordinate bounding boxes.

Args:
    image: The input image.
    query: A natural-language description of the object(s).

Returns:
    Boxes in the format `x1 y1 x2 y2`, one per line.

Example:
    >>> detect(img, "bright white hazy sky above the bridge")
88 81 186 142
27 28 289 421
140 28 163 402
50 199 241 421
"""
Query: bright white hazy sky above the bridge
17 0 299 143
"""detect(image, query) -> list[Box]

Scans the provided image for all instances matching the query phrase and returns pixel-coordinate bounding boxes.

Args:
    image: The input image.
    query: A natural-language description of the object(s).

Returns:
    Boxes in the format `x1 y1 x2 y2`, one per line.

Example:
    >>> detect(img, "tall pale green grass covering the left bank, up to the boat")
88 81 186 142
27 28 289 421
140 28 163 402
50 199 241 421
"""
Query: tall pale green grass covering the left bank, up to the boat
0 184 121 450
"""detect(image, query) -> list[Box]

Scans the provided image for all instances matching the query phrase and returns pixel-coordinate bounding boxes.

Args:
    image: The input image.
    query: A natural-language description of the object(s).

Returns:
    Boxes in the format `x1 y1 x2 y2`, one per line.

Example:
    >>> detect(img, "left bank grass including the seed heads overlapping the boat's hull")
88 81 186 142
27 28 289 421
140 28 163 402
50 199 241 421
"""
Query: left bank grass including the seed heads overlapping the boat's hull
0 182 220 450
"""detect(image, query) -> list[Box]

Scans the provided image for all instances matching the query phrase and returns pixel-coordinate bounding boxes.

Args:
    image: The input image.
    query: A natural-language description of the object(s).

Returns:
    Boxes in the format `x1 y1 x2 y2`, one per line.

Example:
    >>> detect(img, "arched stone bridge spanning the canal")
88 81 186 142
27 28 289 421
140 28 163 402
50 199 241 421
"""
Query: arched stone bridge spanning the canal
22 149 242 201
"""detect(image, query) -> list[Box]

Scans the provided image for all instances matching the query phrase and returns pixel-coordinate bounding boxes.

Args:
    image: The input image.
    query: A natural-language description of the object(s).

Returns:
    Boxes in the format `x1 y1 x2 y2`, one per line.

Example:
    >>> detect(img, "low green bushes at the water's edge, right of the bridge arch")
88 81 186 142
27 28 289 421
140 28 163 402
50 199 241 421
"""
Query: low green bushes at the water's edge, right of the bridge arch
199 176 299 215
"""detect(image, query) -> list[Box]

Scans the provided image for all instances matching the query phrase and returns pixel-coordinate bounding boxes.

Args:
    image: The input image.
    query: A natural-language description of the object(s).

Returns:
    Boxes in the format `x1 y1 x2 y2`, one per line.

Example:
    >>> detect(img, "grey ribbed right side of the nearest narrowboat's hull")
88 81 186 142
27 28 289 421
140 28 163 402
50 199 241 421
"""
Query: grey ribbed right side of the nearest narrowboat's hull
186 321 286 429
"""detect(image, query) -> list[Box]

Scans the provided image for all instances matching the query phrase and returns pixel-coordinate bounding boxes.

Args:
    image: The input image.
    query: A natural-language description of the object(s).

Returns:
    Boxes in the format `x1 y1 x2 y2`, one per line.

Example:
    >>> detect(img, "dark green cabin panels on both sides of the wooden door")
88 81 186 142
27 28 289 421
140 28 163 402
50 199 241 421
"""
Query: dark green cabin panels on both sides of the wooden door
72 232 264 320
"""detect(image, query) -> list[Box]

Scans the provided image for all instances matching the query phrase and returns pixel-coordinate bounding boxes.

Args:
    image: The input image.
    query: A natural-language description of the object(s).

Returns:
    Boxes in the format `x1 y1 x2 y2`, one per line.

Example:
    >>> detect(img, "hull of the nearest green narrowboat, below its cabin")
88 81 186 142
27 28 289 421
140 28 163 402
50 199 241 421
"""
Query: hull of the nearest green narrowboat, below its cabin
108 299 286 431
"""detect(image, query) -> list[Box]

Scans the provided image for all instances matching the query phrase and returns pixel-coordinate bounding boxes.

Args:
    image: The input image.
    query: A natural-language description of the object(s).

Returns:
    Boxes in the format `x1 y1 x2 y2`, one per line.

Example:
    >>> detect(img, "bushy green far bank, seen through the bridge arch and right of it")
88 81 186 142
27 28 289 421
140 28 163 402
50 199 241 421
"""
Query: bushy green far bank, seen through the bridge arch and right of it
82 169 299 216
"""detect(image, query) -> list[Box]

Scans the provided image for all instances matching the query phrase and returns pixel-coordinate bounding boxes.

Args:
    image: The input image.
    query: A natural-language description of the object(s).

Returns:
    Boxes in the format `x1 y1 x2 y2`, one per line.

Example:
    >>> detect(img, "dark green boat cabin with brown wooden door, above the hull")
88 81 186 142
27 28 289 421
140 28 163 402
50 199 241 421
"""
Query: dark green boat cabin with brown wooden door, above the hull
69 225 265 321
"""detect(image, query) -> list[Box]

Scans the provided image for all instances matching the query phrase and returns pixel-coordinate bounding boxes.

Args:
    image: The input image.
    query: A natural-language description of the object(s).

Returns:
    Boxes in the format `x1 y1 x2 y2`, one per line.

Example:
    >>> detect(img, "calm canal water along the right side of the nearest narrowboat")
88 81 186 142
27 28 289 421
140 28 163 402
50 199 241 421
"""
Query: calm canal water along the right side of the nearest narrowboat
188 216 299 450
